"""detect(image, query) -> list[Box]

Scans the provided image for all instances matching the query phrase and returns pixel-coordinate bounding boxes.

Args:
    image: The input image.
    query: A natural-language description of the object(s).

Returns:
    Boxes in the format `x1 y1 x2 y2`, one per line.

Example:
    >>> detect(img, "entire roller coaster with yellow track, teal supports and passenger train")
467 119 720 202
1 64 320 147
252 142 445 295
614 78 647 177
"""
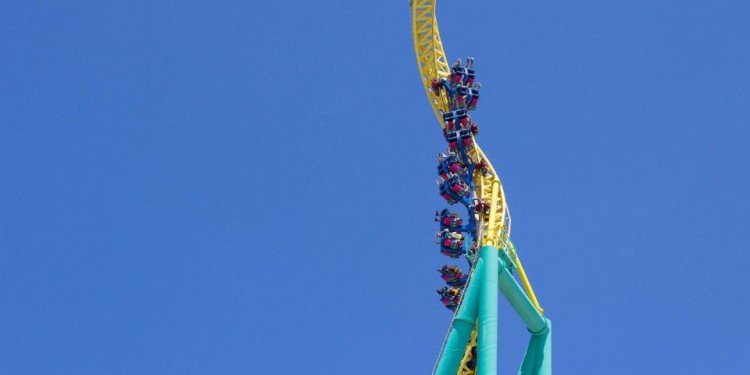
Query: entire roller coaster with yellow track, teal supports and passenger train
409 0 552 375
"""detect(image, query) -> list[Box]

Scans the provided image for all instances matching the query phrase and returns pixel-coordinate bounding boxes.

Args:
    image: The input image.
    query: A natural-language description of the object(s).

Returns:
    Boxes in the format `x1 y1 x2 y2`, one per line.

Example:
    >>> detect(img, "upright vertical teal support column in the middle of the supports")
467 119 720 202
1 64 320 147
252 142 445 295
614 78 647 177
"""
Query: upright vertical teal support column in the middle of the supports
477 246 499 375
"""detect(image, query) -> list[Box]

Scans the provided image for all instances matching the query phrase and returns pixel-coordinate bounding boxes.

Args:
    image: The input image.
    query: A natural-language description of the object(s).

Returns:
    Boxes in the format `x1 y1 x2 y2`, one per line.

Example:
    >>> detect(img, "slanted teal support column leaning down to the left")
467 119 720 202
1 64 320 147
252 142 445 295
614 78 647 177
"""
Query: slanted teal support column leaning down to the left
433 259 488 375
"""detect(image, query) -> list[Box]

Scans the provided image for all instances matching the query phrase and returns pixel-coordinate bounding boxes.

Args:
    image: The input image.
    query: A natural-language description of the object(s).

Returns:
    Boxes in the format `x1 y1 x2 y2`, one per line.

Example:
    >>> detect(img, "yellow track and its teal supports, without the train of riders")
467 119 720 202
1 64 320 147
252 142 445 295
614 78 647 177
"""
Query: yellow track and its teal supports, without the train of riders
409 0 551 375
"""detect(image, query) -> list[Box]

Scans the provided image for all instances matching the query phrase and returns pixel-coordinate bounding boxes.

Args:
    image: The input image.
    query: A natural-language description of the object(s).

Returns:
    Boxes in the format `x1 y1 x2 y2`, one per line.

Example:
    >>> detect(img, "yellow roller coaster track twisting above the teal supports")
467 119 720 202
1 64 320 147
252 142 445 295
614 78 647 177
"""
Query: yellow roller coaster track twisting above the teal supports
409 0 543 375
